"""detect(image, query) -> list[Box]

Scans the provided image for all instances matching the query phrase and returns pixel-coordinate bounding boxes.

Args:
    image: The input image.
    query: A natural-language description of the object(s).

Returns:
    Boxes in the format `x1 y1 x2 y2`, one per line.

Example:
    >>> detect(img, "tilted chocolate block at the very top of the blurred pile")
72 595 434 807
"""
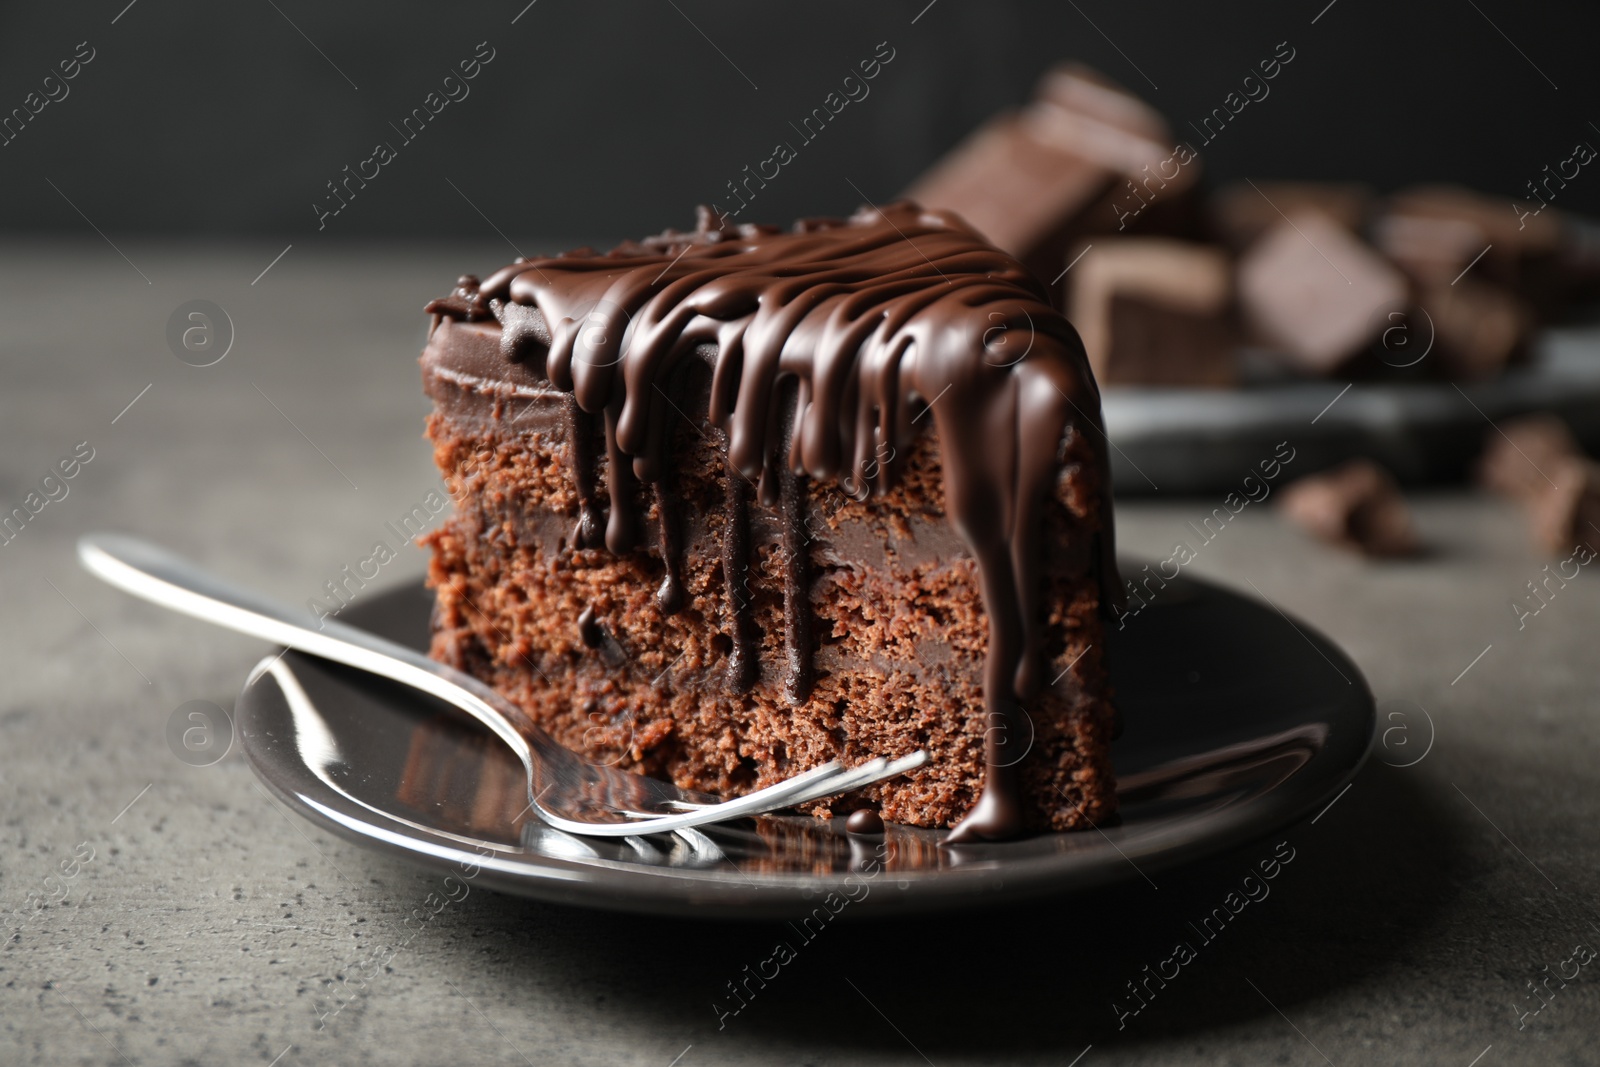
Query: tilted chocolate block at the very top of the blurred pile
906 64 1200 282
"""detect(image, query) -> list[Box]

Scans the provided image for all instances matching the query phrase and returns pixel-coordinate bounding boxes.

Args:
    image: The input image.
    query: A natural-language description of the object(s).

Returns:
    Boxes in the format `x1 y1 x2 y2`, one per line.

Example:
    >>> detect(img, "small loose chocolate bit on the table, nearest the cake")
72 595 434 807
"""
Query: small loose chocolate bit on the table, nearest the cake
1278 459 1419 557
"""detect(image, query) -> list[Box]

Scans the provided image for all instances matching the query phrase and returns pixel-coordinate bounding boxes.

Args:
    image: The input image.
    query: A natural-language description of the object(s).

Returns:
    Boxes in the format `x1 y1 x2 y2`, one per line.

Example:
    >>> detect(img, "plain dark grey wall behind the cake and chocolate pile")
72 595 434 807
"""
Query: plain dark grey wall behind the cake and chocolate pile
0 0 1600 244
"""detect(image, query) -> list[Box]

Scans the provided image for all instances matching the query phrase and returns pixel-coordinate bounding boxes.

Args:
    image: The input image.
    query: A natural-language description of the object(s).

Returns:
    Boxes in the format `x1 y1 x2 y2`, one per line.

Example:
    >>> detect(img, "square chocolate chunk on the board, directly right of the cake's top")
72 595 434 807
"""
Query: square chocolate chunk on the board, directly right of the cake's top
1067 237 1238 386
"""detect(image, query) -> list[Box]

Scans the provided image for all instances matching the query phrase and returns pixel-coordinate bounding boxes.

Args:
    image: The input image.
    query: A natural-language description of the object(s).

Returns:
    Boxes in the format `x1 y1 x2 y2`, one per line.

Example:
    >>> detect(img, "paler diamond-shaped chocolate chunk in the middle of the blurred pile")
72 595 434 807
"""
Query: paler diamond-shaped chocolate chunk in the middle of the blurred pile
1238 211 1408 374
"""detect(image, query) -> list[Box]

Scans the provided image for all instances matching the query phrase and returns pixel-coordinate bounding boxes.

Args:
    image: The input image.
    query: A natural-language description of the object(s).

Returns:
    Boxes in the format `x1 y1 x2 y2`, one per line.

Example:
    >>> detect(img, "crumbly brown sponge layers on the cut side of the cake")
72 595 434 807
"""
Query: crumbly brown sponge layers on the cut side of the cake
422 318 1115 830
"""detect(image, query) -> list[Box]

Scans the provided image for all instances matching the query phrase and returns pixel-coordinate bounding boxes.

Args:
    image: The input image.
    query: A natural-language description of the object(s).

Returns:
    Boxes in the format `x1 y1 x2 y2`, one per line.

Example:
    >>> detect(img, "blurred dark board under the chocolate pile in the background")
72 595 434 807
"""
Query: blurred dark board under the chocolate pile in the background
1101 326 1600 496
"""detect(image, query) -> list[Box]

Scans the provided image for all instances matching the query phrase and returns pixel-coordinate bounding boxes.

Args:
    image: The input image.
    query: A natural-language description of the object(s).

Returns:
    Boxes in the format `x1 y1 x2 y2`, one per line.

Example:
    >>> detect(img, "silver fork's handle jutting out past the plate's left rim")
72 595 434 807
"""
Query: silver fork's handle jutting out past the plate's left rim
78 534 534 771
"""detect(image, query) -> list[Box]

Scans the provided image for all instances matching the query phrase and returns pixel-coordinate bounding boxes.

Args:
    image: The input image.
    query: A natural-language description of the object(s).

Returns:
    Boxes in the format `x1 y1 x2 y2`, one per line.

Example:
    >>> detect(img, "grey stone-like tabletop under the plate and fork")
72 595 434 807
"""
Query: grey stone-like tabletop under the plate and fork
0 242 1600 1067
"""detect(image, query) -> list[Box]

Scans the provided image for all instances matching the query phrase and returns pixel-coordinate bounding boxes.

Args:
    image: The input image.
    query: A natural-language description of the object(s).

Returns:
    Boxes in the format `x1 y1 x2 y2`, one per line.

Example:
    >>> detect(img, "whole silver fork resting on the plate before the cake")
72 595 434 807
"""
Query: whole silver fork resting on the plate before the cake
78 534 928 837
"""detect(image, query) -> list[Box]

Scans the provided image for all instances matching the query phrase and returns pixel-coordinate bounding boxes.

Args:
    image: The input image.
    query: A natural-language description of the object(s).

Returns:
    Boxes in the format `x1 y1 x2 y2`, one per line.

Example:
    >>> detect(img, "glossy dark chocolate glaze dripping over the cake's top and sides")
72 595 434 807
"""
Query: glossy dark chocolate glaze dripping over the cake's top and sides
429 203 1120 841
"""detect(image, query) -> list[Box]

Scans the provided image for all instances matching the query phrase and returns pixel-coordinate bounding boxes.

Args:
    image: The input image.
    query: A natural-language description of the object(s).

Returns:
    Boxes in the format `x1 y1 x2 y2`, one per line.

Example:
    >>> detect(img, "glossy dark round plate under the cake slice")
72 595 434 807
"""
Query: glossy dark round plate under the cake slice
237 579 1374 918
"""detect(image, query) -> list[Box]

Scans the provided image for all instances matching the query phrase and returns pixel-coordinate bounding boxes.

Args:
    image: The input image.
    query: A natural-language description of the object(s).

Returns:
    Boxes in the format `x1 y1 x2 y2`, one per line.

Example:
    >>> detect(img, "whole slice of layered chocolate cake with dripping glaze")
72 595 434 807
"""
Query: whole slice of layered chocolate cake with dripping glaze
422 203 1120 841
